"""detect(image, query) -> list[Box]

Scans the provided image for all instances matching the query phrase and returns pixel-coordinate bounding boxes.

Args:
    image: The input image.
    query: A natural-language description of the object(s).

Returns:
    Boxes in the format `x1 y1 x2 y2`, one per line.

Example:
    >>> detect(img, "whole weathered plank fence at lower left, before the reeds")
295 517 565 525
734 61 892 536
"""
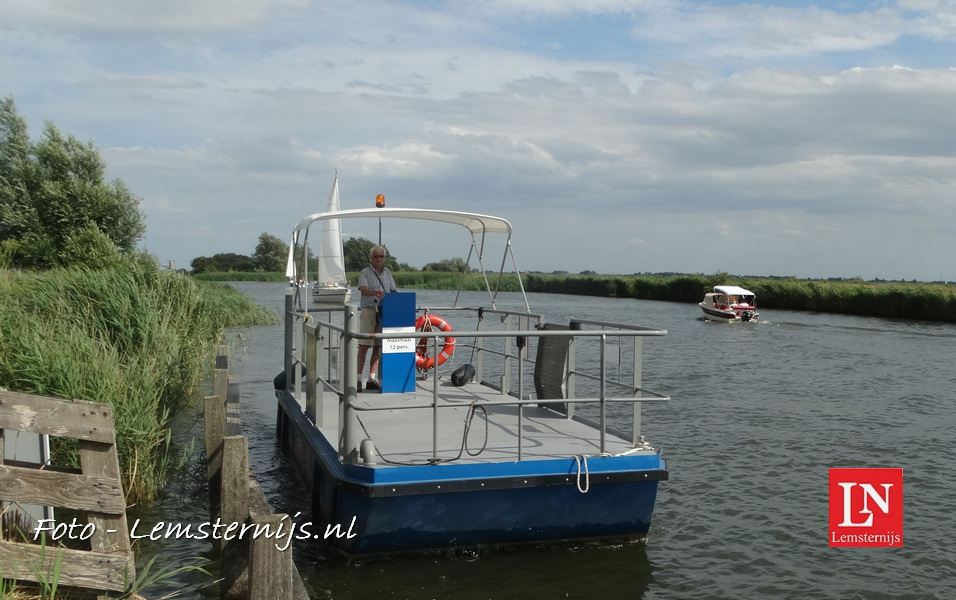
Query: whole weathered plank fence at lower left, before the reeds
0 390 136 594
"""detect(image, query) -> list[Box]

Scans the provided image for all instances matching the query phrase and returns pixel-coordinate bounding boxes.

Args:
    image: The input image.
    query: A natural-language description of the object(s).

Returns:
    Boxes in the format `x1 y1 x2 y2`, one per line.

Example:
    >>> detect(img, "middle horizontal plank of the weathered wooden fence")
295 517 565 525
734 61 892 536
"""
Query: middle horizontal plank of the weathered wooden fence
0 465 126 515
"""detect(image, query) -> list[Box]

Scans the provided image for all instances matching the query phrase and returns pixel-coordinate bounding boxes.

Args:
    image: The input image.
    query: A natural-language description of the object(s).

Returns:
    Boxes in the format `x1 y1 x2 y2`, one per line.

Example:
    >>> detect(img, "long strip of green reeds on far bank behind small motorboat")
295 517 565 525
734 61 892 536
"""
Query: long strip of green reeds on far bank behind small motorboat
525 273 956 322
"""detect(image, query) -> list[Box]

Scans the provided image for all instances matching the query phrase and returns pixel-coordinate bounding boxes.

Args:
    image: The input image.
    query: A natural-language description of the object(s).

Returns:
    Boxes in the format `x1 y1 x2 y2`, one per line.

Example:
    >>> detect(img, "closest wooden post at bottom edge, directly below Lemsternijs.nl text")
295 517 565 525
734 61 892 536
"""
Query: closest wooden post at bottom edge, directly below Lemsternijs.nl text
249 515 293 598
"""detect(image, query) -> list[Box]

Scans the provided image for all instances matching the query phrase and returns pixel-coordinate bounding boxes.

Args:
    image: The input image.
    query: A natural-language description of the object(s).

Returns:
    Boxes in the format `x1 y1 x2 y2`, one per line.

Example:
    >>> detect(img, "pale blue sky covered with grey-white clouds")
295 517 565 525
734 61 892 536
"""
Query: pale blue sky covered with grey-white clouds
0 0 956 281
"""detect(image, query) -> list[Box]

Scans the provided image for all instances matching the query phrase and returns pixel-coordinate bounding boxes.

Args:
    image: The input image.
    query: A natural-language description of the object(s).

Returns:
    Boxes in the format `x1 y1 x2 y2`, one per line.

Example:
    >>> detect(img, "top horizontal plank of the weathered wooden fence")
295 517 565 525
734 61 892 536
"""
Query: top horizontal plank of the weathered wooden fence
0 390 116 444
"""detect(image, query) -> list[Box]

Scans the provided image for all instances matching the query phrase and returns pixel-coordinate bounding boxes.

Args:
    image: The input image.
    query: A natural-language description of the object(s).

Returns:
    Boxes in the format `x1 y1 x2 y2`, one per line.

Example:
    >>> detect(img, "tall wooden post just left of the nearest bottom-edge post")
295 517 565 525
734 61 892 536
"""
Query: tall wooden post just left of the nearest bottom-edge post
220 435 251 598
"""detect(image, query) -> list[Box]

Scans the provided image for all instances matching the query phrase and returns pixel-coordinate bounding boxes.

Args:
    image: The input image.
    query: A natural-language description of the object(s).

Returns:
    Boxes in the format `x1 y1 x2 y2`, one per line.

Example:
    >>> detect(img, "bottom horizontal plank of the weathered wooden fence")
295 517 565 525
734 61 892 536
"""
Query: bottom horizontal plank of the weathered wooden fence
0 541 135 591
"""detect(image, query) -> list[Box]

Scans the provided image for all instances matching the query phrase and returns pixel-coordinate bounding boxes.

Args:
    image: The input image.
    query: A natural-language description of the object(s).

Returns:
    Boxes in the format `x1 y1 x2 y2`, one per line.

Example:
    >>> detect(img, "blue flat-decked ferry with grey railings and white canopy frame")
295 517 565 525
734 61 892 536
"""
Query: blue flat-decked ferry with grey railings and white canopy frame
276 208 668 555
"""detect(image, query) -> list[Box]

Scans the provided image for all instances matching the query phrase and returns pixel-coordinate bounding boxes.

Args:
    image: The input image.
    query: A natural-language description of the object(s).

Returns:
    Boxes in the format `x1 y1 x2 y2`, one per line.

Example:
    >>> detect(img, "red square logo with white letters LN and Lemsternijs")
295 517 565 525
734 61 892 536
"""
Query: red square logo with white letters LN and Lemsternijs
830 469 903 547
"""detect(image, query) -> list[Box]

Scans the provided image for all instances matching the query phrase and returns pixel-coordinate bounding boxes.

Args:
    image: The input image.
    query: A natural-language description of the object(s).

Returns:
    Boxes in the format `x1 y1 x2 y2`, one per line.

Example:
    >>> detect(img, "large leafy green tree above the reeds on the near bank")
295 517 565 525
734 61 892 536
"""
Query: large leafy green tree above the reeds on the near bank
0 97 146 268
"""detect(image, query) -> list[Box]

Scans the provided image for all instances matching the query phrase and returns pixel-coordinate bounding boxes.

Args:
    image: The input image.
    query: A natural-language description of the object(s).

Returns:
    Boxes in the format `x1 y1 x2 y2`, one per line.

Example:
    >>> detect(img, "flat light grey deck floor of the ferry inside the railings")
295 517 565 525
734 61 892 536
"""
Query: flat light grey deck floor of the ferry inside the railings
299 379 634 466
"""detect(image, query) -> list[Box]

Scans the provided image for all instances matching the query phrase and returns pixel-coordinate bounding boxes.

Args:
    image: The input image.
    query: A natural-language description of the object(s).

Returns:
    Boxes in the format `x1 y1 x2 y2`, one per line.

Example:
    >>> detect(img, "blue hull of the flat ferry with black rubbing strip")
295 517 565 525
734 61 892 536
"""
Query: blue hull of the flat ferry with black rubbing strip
277 392 667 555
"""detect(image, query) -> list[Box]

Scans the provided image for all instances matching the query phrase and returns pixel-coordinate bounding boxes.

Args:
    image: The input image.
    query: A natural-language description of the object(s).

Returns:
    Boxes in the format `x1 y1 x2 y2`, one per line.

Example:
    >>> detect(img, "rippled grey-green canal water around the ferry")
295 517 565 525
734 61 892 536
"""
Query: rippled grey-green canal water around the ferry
144 283 956 600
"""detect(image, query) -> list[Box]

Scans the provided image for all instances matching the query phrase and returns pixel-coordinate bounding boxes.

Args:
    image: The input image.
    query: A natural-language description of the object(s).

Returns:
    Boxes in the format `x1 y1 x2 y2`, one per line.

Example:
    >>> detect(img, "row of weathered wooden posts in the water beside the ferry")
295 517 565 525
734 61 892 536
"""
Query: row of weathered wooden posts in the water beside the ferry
204 346 308 600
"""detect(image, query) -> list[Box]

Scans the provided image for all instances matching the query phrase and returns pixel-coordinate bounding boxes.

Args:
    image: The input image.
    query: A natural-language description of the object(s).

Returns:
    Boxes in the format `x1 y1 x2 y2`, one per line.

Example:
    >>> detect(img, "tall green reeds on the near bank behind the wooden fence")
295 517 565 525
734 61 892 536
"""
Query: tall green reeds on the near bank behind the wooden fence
0 260 275 504
